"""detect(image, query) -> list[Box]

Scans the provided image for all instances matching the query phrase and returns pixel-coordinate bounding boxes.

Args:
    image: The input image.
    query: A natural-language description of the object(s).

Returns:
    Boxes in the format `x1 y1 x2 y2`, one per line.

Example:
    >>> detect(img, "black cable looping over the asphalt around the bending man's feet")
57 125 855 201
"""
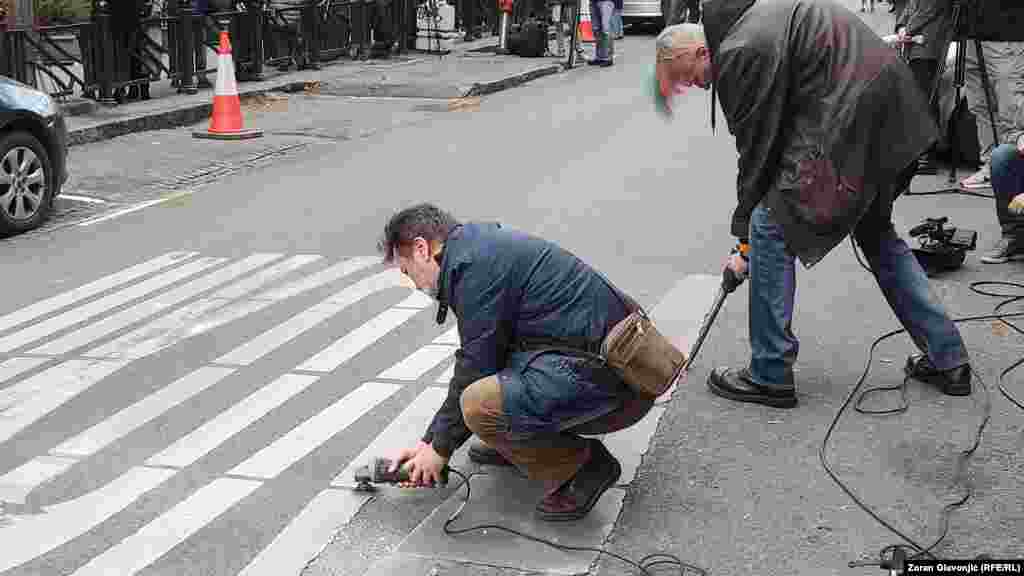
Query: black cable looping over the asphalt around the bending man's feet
835 238 1024 568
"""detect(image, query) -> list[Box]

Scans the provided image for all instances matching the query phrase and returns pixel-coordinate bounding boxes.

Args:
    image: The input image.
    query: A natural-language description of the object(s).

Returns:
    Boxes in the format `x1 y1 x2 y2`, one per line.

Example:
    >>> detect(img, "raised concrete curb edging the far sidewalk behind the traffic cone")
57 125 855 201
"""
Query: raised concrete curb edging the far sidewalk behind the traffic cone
69 59 567 147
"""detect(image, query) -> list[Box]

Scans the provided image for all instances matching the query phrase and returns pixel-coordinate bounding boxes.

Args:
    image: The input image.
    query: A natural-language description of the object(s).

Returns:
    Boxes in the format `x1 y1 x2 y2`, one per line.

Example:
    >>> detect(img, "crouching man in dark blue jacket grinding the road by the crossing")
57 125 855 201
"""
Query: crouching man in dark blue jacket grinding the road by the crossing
379 204 654 521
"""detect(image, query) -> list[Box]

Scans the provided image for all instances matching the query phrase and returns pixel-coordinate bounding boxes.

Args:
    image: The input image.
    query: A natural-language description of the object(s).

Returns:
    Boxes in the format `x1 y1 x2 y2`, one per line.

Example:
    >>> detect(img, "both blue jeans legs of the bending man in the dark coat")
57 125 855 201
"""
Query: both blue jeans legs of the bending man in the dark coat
750 192 968 386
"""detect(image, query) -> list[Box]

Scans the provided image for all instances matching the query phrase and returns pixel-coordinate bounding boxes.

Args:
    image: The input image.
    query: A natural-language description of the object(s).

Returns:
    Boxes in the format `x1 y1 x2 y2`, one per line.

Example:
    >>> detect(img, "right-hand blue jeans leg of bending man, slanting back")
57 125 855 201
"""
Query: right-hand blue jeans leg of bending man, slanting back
854 177 969 370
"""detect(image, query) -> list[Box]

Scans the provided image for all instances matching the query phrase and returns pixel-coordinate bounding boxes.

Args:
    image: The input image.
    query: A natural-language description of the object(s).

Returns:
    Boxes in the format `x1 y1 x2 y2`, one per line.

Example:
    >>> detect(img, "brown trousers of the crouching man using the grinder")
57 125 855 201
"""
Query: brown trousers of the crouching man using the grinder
461 376 654 491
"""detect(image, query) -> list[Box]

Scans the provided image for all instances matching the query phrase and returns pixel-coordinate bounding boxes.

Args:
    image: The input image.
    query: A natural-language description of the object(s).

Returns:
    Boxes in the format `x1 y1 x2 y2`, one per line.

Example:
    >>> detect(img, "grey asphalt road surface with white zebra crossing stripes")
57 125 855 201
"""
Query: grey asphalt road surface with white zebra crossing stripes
0 5 1024 576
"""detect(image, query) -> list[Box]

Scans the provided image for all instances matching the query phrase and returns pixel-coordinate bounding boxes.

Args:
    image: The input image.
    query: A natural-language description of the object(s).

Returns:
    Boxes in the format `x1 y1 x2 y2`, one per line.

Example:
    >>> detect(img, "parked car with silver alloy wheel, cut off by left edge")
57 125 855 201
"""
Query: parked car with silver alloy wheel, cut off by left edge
0 76 68 236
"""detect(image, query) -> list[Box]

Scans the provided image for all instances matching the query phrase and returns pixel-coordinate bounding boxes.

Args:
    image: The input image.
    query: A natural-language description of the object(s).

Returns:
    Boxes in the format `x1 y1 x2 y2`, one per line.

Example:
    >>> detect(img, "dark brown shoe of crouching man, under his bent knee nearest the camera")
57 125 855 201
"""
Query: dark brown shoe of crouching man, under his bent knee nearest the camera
537 439 623 522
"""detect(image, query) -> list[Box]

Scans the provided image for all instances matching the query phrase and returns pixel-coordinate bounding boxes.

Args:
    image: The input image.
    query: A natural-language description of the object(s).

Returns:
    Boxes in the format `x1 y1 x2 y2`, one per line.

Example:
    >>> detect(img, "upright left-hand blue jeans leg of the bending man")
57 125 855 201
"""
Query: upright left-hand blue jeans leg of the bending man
749 205 800 386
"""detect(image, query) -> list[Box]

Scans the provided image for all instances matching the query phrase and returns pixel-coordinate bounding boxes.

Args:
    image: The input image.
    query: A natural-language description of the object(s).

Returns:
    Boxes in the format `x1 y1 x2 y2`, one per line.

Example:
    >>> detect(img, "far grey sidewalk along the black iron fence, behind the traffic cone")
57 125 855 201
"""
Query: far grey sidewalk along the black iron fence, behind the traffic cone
65 37 566 146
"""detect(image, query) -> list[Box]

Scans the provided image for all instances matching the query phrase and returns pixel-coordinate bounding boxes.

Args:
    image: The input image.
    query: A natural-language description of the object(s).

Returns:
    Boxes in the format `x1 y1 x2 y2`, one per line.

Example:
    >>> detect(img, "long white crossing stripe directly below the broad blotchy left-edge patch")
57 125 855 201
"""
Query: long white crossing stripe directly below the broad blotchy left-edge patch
0 366 234 503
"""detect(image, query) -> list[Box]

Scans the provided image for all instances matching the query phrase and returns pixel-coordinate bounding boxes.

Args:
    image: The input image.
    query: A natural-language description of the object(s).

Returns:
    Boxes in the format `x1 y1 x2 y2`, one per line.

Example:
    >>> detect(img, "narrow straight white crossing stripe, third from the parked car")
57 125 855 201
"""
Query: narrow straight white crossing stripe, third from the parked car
32 254 281 355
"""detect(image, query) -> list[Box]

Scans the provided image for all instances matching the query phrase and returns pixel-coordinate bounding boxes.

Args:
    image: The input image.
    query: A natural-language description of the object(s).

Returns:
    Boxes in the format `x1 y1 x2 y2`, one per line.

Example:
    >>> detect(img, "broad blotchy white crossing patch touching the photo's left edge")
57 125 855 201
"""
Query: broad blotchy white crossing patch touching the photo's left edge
0 360 127 443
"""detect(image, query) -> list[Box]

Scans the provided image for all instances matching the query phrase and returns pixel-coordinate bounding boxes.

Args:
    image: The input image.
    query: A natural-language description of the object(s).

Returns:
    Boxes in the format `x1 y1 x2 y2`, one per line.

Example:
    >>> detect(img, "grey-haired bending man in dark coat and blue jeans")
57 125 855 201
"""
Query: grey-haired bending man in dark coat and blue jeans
654 0 971 408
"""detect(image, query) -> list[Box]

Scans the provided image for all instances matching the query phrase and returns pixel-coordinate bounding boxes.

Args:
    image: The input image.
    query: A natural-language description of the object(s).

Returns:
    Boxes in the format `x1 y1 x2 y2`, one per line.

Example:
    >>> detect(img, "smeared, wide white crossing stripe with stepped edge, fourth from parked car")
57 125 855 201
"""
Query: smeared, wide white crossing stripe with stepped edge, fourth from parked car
83 256 319 359
